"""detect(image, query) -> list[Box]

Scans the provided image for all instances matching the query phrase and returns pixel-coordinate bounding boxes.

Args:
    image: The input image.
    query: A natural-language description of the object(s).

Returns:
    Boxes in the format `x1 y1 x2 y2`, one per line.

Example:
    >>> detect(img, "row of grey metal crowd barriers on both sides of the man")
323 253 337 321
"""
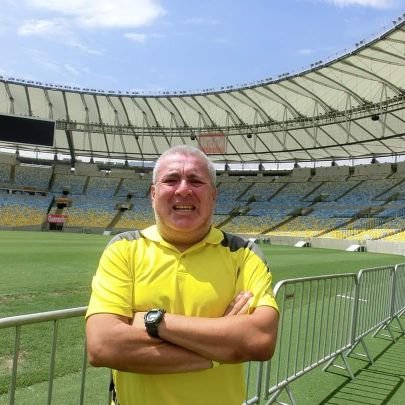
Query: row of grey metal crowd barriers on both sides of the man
0 264 405 405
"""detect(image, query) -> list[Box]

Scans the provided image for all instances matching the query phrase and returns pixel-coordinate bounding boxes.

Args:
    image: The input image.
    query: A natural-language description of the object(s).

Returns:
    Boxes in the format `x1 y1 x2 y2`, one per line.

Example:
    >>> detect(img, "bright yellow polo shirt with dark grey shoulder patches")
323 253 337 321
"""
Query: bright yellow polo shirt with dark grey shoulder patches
86 226 277 405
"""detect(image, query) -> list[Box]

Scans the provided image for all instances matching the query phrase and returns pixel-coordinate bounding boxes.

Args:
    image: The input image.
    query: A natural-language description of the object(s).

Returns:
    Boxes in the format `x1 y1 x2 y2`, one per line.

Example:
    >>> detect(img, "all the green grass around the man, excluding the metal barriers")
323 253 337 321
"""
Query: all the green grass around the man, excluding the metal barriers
0 231 405 405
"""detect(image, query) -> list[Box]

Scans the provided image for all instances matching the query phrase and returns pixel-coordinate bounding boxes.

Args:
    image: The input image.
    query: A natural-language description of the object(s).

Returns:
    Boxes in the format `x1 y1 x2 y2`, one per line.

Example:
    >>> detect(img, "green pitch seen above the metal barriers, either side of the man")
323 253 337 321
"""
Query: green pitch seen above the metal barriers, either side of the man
0 231 405 317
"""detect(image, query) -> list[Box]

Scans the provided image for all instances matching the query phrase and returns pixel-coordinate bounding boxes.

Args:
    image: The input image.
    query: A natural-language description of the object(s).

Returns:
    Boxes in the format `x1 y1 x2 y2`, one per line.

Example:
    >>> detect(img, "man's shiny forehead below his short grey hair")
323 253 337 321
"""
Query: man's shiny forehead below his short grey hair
157 154 209 177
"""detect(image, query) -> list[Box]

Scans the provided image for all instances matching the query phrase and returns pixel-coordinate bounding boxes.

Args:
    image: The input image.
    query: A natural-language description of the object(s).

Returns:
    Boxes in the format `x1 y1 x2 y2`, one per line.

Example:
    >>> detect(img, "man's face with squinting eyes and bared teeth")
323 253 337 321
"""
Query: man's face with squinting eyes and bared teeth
151 154 216 243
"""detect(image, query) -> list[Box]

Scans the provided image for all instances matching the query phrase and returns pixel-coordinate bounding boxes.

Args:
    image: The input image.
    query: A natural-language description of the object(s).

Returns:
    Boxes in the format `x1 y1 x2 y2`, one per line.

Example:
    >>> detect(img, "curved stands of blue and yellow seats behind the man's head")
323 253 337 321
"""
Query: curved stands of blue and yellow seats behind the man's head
0 156 405 251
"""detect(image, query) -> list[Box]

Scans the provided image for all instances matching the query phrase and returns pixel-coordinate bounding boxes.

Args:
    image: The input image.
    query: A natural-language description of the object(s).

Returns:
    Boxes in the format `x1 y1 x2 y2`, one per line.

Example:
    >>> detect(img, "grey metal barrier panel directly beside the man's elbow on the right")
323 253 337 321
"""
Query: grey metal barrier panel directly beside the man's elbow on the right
262 274 356 404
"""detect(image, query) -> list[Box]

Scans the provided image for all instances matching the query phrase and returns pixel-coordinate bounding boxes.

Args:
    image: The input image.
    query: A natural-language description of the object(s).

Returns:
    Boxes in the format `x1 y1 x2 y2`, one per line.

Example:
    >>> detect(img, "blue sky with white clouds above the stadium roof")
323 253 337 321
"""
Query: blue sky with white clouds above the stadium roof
0 0 405 93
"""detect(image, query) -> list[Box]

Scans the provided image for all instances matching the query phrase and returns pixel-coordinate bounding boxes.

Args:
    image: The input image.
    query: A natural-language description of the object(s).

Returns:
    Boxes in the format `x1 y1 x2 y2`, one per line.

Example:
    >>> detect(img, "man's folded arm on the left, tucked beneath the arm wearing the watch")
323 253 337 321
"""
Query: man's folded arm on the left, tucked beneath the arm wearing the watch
86 294 262 374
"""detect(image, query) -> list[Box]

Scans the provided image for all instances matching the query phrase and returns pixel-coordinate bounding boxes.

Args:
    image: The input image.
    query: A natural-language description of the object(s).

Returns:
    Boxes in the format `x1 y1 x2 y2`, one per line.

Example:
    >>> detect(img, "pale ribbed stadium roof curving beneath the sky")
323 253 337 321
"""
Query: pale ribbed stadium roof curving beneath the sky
0 18 405 162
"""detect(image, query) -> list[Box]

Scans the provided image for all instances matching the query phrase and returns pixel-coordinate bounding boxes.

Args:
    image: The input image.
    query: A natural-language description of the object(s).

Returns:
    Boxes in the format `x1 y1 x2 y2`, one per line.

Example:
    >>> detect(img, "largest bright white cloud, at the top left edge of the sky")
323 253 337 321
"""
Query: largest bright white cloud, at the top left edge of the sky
26 0 166 28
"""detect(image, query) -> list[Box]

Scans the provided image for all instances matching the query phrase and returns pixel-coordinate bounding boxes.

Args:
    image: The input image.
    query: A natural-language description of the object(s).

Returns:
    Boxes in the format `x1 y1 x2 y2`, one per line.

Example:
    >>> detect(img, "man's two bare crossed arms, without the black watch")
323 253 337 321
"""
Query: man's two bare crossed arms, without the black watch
86 293 278 374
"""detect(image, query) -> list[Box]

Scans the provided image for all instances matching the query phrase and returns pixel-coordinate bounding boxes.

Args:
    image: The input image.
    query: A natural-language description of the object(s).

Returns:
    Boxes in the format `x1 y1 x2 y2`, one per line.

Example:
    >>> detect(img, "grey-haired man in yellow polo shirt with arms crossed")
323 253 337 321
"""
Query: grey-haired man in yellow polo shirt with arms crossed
86 146 278 405
